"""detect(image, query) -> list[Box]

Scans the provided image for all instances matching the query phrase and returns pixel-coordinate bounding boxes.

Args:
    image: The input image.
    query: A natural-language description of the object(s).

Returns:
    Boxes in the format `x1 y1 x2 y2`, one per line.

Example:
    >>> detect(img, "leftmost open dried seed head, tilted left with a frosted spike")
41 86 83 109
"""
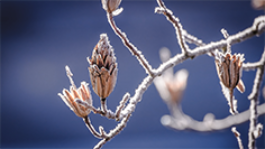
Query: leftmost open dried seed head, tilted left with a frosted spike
58 66 92 118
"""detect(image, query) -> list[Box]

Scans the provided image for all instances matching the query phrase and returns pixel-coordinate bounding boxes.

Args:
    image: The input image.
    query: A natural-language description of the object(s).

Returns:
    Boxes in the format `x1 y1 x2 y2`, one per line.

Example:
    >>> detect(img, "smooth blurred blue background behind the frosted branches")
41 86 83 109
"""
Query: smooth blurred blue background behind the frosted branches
0 0 265 148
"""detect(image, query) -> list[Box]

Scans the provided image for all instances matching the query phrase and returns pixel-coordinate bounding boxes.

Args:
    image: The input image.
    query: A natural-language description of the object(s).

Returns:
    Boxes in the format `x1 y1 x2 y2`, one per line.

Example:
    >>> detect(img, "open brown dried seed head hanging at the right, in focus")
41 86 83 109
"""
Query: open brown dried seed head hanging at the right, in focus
215 53 245 93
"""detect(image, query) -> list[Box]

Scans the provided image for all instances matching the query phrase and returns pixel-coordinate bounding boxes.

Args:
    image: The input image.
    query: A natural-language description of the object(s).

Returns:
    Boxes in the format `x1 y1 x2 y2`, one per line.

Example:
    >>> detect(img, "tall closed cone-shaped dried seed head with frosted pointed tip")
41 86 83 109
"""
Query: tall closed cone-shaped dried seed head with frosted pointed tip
87 34 118 100
